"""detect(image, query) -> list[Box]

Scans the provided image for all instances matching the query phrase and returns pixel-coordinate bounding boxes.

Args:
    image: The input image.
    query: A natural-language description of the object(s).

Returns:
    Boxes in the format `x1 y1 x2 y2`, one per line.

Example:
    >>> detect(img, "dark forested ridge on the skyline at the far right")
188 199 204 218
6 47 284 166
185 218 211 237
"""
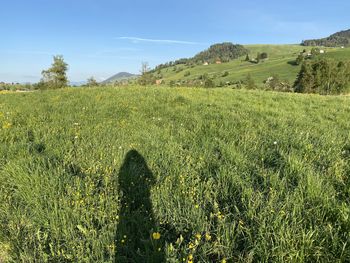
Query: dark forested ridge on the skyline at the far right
301 29 350 47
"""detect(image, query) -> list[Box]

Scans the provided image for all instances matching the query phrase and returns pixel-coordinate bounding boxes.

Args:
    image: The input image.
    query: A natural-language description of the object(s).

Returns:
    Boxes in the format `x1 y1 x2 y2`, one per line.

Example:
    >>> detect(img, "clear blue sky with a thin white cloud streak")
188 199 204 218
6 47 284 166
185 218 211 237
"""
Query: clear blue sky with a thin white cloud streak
0 0 350 82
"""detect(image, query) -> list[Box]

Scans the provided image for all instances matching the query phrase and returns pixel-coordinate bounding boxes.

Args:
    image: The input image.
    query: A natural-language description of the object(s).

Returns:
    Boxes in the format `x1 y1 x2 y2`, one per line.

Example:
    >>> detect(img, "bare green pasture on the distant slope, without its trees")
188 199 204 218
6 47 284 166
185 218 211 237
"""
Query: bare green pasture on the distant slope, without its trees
162 45 350 85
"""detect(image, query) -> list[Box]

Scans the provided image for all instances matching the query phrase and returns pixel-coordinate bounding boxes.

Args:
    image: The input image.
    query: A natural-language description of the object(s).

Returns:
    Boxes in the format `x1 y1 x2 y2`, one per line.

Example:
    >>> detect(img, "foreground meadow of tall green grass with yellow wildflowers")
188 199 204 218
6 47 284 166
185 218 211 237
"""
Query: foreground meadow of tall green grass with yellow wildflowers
0 86 350 262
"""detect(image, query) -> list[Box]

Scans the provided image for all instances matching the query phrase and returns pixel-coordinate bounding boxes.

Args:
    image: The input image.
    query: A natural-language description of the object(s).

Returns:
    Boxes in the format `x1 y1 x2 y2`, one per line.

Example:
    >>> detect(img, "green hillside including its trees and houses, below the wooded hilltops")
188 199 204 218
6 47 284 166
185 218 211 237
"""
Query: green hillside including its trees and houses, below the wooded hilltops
151 44 350 94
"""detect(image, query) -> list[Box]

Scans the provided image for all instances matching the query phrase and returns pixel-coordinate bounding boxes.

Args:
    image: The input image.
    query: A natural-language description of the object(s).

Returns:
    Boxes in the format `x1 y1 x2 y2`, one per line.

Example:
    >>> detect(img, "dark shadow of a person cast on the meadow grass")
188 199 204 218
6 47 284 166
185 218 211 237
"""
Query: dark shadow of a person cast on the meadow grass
115 150 165 263
